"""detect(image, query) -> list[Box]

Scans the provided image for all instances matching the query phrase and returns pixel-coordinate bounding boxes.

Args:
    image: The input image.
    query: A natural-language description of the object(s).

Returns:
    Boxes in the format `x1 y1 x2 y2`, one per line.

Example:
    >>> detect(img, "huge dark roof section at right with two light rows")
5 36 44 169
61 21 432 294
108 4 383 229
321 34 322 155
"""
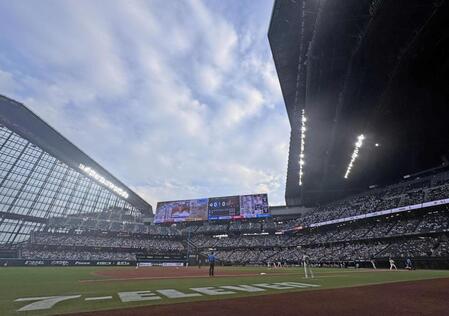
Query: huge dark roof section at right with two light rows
268 0 449 205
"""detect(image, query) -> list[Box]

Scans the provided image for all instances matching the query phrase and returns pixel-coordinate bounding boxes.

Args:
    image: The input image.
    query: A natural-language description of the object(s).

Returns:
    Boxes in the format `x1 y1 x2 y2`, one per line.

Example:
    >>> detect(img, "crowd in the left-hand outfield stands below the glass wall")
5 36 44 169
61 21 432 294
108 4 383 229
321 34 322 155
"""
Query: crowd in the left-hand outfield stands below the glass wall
22 208 185 261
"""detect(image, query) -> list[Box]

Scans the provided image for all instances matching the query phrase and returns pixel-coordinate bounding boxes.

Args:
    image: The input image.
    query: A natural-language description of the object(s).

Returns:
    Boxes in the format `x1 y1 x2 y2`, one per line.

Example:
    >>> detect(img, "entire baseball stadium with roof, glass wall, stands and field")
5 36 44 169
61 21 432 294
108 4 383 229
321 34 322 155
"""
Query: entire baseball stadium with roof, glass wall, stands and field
0 0 449 316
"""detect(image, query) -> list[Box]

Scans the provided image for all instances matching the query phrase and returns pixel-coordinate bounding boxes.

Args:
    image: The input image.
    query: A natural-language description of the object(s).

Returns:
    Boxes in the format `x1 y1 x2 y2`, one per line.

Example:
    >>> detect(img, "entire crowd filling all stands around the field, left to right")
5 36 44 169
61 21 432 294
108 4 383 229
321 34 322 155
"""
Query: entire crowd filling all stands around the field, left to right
18 172 449 264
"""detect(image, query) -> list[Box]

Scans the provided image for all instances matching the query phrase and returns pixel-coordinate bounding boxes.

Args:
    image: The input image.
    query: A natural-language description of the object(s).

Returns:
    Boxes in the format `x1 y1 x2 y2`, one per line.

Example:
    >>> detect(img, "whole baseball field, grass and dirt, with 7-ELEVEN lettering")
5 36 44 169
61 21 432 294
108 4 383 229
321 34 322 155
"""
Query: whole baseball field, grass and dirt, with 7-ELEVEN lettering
0 267 449 316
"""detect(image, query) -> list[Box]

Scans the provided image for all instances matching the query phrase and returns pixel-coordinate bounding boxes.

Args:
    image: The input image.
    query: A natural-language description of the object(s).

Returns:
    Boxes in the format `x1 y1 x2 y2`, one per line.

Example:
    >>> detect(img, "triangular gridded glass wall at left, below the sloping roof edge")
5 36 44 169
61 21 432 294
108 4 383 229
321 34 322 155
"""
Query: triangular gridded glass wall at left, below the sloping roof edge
0 125 145 244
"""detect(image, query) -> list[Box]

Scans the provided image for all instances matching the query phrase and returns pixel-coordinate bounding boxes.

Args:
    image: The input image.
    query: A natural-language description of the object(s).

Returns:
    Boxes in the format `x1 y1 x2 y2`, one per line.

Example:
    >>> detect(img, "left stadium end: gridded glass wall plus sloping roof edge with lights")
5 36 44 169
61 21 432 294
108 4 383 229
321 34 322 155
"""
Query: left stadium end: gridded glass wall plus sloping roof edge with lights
0 96 152 246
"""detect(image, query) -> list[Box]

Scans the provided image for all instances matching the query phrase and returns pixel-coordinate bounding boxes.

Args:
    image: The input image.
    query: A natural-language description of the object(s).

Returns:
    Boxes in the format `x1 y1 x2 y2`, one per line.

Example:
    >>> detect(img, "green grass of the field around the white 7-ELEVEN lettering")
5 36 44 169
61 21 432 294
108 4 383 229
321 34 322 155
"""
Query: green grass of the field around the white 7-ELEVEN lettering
0 267 449 315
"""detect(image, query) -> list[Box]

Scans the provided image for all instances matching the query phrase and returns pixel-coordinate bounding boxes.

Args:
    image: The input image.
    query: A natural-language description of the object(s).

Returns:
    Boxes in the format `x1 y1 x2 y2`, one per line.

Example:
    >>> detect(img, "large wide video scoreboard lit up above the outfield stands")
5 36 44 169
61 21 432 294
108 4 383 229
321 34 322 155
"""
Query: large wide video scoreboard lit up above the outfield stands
154 194 271 224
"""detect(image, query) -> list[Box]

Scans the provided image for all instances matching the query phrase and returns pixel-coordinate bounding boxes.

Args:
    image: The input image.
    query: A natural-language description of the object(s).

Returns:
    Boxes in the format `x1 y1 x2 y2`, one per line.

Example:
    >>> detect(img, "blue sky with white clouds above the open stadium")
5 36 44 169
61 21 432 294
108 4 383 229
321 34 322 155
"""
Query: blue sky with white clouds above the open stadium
0 0 289 206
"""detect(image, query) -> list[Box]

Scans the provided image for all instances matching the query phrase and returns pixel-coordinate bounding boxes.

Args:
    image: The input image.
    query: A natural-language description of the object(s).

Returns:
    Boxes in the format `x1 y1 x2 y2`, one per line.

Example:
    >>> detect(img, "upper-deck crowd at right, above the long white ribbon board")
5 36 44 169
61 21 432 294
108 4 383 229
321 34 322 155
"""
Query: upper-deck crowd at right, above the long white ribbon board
168 175 449 236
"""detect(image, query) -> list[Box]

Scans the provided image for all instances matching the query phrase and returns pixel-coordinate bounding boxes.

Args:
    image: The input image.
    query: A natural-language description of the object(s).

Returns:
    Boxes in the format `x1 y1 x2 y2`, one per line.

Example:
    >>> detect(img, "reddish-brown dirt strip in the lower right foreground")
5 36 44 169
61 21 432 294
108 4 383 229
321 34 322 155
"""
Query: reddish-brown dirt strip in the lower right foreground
69 278 449 316
